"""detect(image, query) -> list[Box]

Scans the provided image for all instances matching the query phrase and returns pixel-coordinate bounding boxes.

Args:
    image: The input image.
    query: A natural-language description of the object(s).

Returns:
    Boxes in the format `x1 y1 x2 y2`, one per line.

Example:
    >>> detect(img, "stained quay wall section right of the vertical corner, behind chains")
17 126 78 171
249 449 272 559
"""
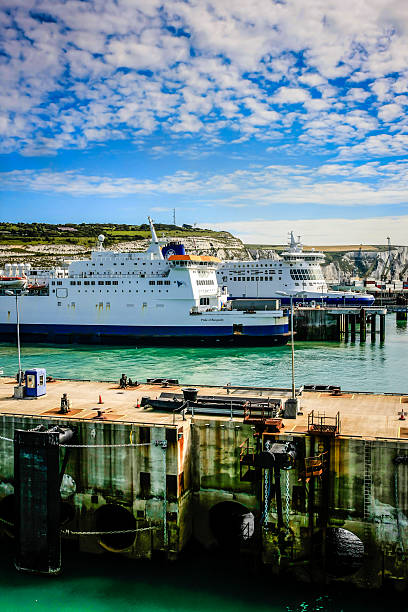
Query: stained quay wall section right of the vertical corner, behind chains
186 421 408 587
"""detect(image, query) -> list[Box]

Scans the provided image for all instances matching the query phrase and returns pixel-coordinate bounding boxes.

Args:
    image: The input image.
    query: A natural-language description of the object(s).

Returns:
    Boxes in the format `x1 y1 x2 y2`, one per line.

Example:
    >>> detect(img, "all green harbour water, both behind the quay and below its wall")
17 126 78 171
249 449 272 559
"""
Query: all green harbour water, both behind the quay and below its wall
0 314 408 612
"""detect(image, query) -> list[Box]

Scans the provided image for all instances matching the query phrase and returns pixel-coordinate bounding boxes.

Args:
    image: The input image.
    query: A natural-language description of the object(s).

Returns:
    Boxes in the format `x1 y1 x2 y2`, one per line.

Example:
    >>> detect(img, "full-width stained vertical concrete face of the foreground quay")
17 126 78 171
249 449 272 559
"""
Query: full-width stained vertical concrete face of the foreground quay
0 415 408 588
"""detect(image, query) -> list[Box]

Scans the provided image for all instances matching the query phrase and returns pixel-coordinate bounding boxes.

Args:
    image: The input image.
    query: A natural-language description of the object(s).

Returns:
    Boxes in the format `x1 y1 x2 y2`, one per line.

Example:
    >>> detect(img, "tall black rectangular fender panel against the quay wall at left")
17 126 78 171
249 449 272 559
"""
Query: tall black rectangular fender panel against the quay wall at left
14 425 74 574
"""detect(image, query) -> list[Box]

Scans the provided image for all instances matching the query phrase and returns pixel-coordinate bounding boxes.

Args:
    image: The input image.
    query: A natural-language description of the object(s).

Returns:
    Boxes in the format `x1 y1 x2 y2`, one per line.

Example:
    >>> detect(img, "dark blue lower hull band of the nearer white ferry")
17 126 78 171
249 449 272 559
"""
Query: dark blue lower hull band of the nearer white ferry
0 324 290 346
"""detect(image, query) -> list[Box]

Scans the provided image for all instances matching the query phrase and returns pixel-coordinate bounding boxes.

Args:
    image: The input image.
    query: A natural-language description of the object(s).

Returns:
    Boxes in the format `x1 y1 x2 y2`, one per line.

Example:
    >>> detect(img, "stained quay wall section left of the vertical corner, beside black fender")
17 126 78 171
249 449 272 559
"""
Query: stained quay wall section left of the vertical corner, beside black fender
0 416 191 557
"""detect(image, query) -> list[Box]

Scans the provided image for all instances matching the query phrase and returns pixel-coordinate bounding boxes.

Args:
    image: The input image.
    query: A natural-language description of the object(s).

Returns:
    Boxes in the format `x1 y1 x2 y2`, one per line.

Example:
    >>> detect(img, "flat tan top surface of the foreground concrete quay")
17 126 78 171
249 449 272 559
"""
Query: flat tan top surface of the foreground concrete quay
0 377 408 441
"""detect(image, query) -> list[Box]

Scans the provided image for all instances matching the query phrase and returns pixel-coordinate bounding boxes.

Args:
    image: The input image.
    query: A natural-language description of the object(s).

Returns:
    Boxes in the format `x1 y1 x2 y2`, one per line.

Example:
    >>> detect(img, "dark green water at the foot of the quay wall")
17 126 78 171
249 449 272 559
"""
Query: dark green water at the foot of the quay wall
0 553 407 612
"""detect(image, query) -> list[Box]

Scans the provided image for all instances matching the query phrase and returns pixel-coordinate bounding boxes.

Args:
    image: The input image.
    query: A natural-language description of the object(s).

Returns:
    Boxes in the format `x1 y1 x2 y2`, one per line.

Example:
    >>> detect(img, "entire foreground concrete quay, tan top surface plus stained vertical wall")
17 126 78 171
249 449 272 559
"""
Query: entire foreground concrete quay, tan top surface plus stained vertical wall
0 378 408 590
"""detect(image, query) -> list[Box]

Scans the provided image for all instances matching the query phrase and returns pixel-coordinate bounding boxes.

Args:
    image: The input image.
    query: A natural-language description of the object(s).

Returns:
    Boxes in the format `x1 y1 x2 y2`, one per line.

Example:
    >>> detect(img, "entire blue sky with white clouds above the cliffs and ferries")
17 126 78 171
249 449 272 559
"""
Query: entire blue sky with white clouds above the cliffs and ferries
0 0 408 244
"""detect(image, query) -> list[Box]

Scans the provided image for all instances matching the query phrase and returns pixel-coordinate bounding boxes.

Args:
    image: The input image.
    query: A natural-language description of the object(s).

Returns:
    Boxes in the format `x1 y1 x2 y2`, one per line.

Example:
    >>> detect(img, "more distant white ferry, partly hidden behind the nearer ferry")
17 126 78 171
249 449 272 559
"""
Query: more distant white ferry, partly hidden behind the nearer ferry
217 232 374 307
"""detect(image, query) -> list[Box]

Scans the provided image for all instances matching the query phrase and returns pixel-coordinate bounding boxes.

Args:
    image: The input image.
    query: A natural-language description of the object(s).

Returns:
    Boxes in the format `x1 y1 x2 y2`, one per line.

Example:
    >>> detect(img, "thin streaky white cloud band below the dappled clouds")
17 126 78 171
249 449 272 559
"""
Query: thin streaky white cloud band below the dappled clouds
0 161 408 209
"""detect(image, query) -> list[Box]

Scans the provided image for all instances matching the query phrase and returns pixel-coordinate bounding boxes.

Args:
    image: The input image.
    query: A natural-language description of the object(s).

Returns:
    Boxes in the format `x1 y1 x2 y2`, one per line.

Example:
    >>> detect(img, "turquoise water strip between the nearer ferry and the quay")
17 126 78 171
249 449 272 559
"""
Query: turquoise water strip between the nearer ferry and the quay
0 314 408 393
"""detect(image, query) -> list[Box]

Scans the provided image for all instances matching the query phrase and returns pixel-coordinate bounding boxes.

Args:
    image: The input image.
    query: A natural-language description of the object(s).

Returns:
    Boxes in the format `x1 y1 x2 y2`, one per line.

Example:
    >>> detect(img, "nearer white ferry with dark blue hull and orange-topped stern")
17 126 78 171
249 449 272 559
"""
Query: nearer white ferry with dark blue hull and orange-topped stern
0 219 288 345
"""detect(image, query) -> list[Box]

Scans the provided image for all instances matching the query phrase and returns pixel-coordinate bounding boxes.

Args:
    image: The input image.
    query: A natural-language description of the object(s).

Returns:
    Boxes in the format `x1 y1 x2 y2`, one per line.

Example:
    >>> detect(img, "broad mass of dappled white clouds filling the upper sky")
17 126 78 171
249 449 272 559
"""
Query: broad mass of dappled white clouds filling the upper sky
0 0 408 159
